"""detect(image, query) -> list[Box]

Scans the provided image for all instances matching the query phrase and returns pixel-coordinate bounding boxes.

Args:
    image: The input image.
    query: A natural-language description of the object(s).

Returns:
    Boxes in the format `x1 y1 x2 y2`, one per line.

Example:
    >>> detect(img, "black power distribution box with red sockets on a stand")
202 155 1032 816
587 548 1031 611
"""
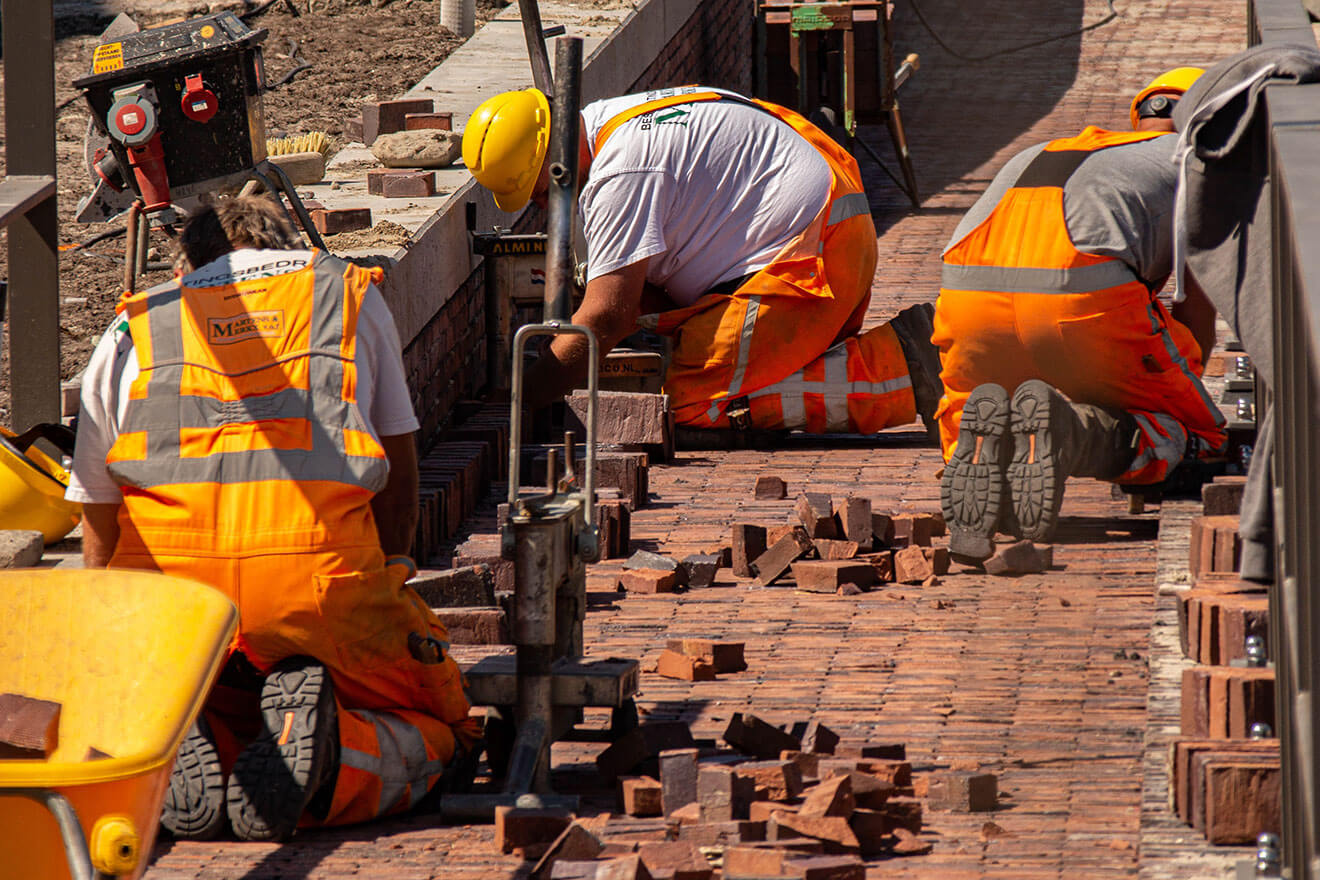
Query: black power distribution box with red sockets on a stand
73 12 325 292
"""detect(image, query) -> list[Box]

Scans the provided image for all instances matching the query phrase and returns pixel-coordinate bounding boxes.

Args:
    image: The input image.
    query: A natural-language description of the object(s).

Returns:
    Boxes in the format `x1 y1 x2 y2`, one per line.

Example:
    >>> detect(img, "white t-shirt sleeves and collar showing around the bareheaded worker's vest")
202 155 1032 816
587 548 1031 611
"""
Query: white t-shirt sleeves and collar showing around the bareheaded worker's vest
65 249 417 504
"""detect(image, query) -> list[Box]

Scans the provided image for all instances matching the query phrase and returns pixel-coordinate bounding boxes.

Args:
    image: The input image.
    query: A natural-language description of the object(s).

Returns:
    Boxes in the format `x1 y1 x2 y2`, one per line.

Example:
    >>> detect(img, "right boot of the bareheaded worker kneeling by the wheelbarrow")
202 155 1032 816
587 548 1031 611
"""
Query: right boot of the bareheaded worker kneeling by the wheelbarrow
227 657 339 840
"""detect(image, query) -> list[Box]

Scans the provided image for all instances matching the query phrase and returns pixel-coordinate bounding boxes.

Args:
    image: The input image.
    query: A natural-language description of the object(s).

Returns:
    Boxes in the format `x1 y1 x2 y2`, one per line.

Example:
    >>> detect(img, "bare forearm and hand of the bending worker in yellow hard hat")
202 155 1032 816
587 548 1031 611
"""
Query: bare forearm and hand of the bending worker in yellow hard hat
523 260 647 410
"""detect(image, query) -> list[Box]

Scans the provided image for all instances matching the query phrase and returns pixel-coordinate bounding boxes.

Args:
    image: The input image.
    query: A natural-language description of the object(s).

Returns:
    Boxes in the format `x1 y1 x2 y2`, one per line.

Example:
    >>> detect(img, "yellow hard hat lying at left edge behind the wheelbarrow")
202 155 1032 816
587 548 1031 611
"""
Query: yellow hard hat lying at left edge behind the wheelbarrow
0 427 82 544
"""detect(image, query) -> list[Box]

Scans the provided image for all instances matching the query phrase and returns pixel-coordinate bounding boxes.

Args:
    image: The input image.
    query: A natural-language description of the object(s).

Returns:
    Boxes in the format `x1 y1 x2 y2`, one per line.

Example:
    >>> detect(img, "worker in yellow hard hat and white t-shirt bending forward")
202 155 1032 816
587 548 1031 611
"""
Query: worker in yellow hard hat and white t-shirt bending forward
463 86 940 437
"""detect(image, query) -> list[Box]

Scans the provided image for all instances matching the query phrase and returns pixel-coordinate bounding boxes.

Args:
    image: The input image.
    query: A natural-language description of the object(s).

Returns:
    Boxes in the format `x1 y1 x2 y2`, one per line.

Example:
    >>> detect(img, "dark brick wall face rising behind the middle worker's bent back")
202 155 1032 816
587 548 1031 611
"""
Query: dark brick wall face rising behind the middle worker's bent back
630 0 754 95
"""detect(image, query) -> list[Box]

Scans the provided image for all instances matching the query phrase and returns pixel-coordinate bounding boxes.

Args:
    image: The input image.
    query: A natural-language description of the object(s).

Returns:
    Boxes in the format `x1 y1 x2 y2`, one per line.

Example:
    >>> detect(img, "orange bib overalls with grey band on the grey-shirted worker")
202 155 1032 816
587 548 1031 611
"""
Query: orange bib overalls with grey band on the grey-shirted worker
932 127 1225 484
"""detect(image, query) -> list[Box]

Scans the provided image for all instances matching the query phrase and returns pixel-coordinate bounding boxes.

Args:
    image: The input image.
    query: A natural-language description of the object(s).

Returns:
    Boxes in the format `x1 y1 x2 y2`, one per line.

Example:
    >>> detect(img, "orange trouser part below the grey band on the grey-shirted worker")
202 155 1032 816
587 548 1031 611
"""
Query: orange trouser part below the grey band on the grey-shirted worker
932 285 1225 486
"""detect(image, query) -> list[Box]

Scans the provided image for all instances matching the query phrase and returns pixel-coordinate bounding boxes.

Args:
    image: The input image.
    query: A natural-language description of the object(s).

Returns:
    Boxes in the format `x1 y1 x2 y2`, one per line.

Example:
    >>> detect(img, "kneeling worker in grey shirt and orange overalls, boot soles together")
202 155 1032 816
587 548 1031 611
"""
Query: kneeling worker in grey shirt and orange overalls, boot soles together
933 67 1225 562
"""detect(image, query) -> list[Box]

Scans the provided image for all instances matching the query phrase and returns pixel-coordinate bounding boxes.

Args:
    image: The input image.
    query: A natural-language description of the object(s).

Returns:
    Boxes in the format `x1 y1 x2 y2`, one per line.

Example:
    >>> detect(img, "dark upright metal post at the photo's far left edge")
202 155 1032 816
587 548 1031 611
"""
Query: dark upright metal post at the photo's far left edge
0 0 61 430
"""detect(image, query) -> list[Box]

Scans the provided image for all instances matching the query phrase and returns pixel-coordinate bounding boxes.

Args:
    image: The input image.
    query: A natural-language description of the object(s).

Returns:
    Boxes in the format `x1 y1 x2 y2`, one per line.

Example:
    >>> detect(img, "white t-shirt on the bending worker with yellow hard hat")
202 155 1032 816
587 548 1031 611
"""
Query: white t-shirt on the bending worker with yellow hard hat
581 86 832 306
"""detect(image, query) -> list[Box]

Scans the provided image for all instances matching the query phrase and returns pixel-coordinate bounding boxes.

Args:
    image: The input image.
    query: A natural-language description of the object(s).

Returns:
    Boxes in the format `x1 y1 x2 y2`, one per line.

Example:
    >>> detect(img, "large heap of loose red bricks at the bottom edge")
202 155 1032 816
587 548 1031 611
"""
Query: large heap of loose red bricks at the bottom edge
495 712 939 880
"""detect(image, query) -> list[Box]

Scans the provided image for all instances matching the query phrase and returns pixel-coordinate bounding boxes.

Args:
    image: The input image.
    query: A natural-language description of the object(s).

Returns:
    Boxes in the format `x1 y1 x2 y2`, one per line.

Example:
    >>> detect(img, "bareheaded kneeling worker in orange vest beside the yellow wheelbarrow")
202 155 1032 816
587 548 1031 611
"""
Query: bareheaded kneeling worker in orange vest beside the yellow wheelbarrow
67 197 478 840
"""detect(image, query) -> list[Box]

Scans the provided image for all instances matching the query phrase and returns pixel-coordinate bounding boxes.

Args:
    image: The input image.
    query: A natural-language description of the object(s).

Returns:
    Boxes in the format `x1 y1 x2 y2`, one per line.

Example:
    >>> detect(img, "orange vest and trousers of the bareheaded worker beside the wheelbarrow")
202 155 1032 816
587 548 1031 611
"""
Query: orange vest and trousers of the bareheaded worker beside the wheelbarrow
107 253 478 825
